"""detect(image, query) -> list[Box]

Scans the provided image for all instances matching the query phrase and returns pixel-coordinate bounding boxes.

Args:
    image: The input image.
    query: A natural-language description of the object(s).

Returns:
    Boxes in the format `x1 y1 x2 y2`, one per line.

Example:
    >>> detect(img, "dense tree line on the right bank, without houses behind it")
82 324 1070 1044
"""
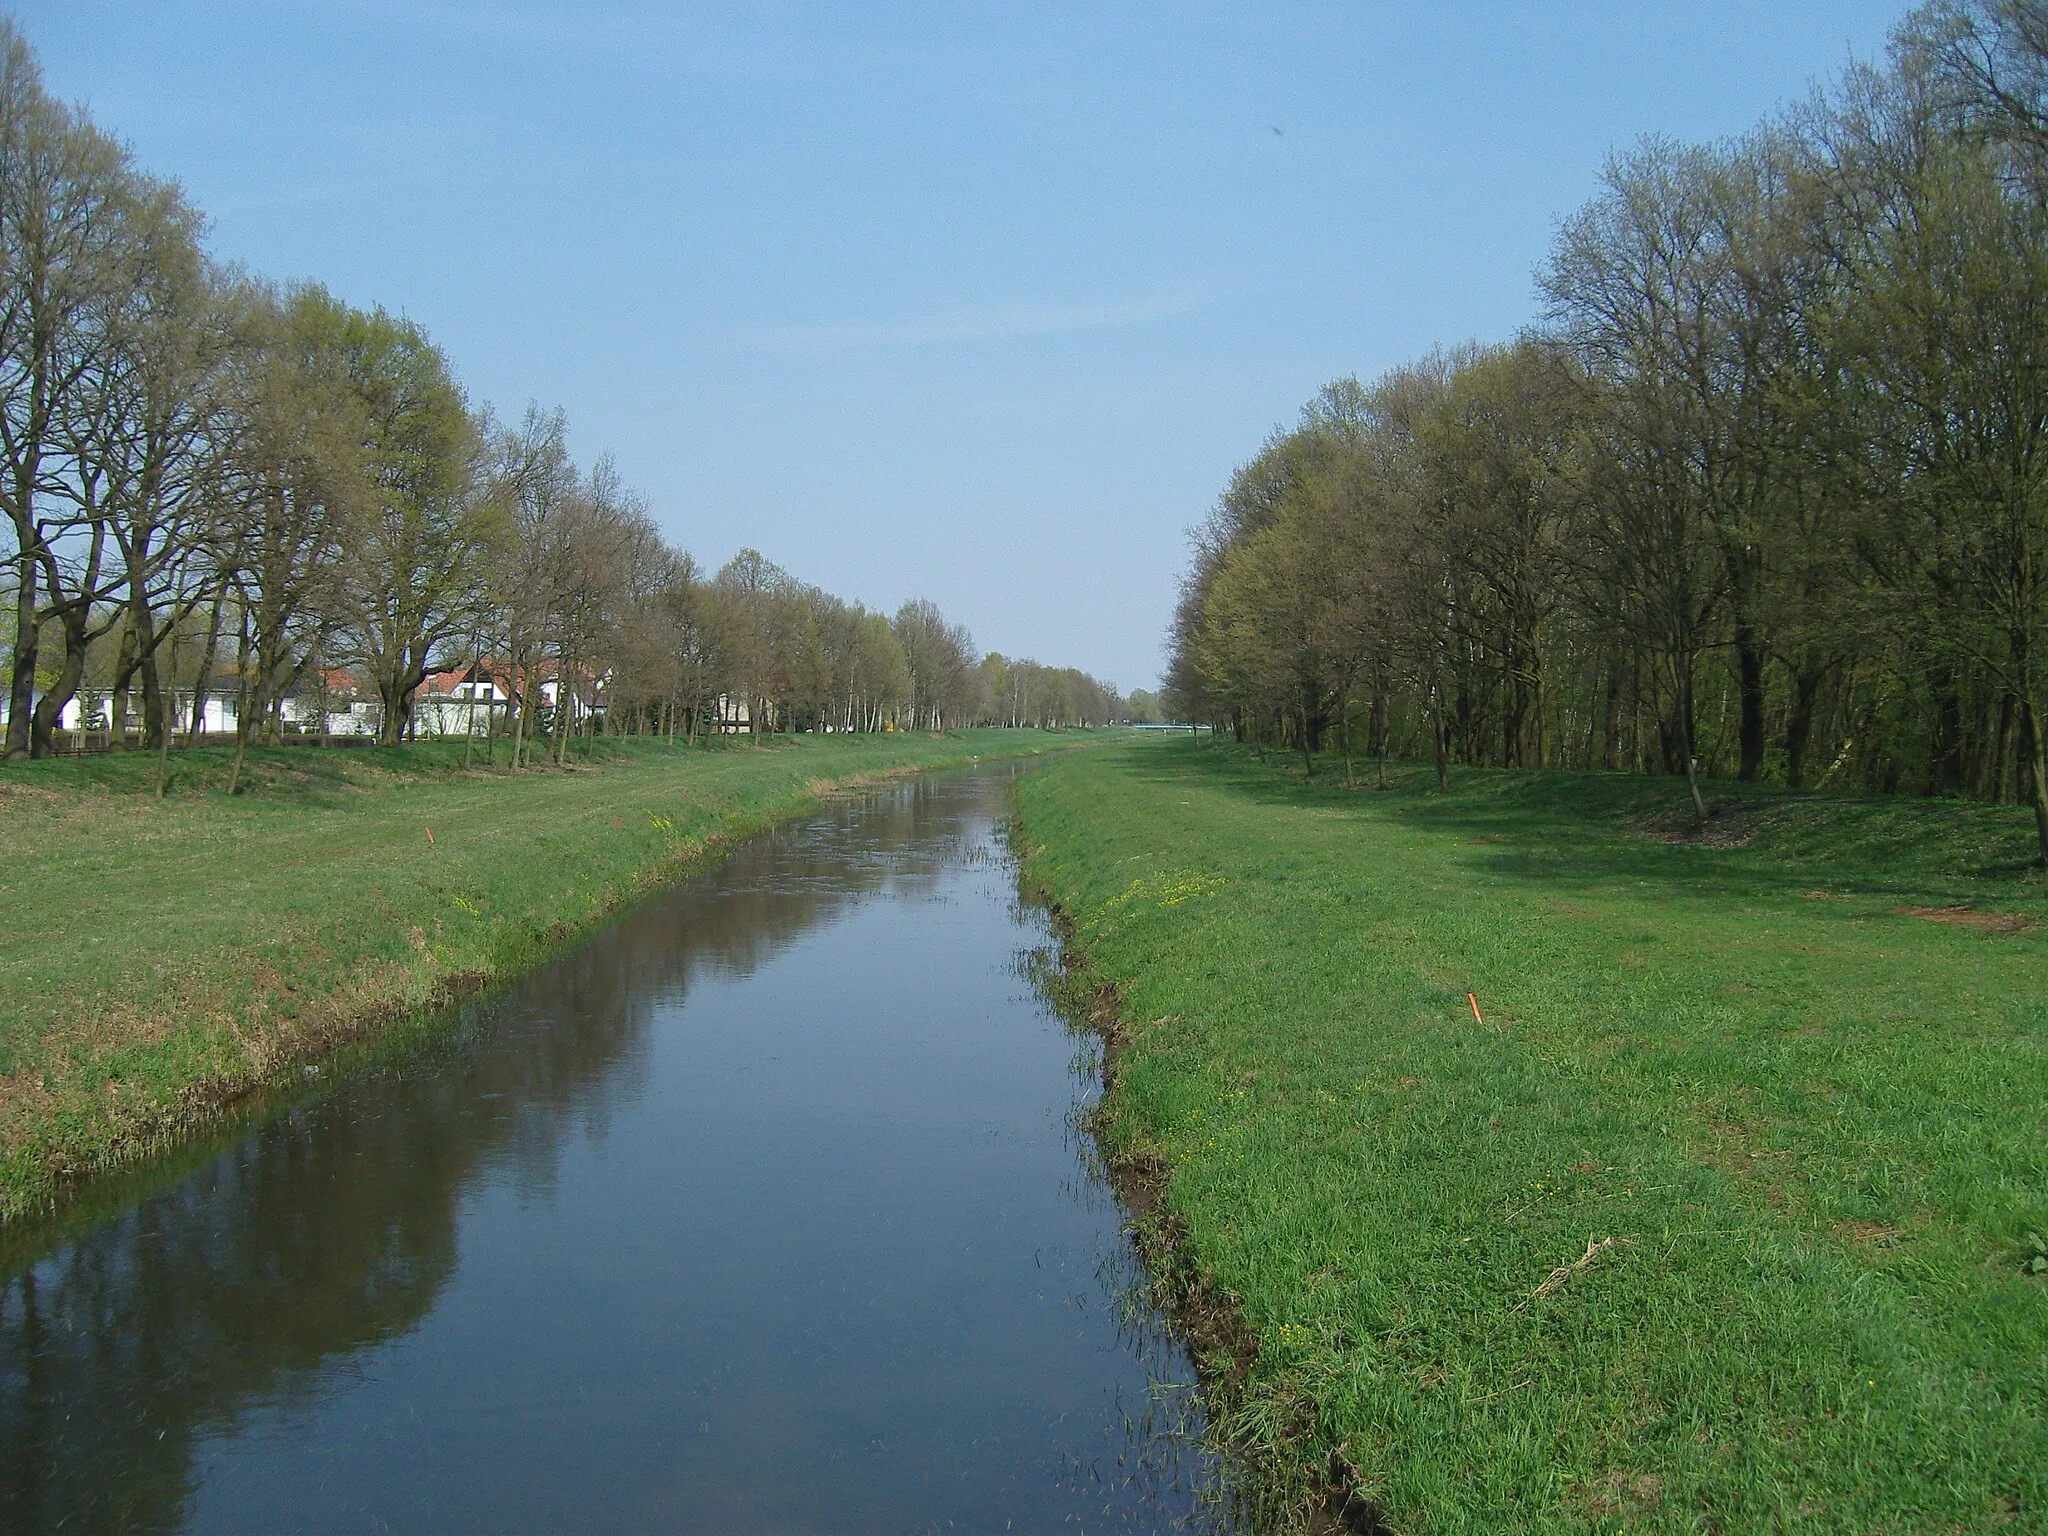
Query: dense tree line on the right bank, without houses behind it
1169 0 2048 856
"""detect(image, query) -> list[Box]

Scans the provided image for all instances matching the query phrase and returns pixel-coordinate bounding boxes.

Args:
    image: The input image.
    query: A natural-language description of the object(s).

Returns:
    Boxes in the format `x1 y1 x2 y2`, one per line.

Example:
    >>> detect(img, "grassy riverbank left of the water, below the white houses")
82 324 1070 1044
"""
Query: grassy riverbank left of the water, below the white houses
0 731 1061 1219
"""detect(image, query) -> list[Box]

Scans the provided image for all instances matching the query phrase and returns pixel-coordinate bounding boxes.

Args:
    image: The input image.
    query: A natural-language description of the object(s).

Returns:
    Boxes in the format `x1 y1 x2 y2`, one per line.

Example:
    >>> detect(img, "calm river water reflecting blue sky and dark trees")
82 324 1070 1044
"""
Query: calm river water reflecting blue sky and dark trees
0 770 1223 1536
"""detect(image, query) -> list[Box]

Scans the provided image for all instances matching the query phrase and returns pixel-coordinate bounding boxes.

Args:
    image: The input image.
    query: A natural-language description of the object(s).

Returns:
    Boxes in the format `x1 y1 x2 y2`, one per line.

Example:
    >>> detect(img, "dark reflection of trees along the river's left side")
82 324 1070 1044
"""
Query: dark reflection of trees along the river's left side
0 780 999 1532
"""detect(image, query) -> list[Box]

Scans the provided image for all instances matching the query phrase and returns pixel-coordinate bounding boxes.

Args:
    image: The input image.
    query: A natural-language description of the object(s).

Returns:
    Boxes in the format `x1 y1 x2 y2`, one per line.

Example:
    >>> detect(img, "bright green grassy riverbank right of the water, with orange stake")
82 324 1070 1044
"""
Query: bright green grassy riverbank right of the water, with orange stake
1020 741 2048 1534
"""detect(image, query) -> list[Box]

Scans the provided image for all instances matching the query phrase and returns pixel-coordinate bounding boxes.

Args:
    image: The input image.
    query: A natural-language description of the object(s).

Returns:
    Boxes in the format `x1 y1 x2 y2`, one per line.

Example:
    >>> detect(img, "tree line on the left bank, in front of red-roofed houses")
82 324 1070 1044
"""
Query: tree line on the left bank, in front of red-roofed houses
0 23 1122 766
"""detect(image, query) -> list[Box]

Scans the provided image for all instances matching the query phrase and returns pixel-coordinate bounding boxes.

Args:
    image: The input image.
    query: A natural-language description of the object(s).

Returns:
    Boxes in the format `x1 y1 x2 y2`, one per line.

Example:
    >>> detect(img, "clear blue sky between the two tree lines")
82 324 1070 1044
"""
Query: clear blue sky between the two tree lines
14 0 1903 688
